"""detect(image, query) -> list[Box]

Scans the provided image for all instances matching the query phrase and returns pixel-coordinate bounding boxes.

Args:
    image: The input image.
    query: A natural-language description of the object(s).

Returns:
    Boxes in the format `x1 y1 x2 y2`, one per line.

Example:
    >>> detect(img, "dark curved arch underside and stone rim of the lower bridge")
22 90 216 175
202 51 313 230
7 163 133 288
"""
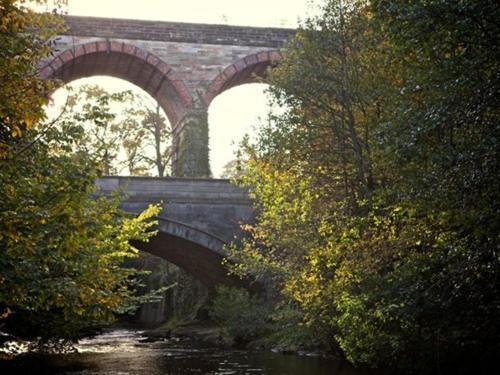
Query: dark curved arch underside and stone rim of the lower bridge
133 220 249 291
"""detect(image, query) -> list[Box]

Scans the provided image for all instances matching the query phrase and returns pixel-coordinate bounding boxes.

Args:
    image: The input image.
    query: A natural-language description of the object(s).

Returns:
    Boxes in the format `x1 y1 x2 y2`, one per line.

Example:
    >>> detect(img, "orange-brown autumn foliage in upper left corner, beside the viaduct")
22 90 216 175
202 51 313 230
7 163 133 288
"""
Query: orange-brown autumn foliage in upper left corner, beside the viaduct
0 0 62 145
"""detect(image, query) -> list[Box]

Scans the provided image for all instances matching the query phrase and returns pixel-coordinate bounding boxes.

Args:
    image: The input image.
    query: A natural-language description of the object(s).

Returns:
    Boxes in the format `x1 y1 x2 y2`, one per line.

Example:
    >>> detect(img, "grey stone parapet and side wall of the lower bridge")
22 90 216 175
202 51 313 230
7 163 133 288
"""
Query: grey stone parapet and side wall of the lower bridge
97 177 253 242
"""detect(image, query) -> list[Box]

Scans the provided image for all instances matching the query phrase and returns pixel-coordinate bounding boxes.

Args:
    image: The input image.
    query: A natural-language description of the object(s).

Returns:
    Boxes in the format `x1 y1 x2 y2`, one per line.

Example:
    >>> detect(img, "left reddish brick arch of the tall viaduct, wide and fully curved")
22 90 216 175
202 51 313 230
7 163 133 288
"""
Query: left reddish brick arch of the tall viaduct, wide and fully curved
40 41 192 124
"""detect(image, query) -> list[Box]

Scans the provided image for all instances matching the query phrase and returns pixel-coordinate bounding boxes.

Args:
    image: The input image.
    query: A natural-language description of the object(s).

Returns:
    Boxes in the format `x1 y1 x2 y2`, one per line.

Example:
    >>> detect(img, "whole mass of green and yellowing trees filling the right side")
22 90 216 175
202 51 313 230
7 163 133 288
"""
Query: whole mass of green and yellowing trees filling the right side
227 0 500 373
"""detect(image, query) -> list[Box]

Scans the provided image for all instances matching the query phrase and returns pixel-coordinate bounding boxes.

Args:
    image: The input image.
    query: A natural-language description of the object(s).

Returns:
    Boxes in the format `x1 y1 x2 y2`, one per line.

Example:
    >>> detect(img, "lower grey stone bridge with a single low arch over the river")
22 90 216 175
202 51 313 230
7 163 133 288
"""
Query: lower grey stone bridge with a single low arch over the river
97 177 253 287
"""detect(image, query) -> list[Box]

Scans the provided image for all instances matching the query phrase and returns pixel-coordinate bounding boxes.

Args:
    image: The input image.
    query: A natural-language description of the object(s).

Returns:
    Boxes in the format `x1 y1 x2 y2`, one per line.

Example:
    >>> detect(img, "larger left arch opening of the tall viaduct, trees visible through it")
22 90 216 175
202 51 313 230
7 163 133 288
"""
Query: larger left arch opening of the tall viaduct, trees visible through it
46 76 172 177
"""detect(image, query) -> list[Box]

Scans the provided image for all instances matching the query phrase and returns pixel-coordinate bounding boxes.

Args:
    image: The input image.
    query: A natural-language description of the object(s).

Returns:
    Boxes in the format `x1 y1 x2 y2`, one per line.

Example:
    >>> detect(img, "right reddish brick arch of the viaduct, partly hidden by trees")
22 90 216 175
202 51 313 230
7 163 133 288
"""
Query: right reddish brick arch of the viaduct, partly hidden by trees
203 51 284 108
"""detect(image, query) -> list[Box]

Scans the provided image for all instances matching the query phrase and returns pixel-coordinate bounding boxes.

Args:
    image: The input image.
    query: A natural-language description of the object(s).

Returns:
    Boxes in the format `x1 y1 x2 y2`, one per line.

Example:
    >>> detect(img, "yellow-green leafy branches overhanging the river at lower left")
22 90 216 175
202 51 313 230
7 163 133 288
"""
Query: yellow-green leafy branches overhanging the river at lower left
0 122 158 346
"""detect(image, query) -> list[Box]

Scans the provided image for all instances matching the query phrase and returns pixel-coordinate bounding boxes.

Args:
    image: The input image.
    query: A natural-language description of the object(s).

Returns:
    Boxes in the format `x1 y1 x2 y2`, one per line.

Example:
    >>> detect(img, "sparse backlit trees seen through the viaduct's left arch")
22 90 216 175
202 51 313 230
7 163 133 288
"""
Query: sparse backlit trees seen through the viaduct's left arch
54 85 170 177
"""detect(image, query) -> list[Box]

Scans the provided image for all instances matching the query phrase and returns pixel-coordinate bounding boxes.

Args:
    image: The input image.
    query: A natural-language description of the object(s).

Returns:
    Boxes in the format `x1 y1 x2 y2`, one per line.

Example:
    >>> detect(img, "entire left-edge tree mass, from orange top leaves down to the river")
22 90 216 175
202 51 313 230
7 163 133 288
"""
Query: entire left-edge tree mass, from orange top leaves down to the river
0 1 157 350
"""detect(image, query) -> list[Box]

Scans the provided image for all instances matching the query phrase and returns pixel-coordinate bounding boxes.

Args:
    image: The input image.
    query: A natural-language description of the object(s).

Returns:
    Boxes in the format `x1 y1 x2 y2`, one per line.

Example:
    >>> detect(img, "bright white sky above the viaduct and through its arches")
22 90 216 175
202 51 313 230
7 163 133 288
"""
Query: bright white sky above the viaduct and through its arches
47 0 318 177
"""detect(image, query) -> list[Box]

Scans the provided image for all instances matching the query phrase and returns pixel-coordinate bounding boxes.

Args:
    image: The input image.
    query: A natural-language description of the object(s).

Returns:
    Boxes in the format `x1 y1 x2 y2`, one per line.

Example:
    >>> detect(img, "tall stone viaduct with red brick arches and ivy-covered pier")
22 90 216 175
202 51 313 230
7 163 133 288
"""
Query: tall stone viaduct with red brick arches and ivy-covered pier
40 16 294 177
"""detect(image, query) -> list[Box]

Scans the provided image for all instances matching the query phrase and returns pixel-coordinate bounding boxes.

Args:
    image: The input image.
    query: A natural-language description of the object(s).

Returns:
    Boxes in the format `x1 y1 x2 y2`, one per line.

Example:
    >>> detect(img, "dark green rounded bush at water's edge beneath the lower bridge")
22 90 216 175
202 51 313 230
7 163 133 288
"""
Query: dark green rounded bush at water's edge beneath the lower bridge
210 286 269 344
